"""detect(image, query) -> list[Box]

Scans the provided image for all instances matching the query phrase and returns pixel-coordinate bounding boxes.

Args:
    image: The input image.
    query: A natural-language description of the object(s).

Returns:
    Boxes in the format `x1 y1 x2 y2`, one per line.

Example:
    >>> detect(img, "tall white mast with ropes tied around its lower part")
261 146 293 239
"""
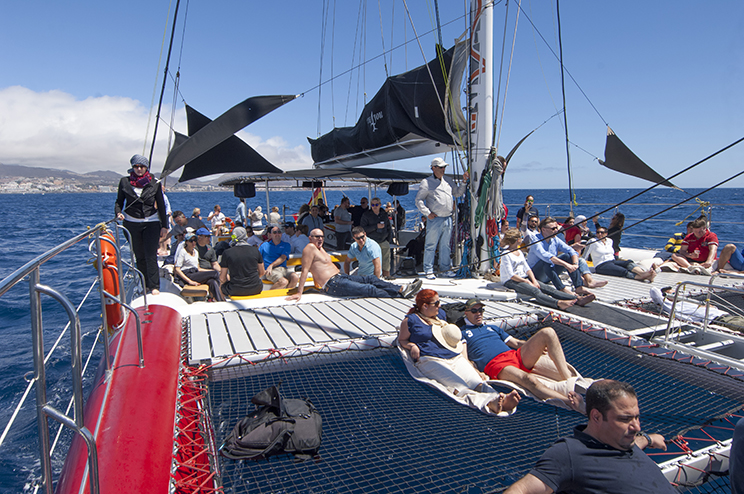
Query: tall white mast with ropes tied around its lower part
468 0 493 273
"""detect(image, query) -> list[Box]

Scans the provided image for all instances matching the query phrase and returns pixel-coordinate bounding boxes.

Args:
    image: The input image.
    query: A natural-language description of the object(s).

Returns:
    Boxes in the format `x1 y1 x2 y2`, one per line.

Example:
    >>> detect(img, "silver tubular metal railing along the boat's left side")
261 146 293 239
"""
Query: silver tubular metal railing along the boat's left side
0 220 147 494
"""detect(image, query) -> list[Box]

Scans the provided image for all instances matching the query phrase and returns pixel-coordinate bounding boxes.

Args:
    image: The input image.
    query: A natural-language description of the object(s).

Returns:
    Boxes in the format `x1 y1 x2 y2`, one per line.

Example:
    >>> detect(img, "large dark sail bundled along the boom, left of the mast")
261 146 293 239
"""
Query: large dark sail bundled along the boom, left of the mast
308 41 468 167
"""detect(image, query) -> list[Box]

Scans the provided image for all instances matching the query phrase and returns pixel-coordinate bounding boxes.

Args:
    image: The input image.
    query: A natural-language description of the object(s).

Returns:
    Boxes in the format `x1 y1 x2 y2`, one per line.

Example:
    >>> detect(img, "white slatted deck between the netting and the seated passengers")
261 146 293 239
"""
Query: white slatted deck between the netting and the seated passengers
187 296 536 364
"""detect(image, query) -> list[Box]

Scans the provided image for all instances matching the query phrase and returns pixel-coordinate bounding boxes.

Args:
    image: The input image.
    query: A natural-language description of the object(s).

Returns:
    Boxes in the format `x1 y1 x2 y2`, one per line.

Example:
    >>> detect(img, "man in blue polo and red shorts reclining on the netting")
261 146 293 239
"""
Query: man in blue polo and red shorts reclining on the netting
462 298 584 413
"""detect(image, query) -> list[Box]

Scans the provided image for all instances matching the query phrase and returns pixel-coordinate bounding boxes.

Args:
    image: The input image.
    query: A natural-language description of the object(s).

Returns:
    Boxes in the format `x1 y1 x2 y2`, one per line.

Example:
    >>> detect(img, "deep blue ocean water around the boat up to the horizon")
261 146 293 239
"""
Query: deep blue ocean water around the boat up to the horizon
0 189 744 492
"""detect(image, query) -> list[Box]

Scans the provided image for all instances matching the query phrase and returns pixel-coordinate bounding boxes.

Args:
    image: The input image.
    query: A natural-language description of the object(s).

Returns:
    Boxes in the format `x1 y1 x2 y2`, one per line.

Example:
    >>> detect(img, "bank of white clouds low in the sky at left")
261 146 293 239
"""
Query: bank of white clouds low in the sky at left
0 86 312 173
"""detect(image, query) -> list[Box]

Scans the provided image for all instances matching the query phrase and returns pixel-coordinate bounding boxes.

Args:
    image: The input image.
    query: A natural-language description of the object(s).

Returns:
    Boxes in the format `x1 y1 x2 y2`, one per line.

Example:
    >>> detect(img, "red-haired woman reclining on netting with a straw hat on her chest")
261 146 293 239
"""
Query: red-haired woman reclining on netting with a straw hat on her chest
398 289 519 414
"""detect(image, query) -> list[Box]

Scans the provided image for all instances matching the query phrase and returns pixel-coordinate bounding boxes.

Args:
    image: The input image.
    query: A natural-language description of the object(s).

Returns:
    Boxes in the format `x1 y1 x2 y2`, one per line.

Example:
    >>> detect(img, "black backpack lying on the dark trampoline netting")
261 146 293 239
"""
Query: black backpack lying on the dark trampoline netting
220 386 322 460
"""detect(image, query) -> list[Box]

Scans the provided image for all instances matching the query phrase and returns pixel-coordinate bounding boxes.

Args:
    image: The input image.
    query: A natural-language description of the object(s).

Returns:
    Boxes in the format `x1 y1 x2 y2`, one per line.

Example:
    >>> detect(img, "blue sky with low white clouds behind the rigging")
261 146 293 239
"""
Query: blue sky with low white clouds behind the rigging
0 0 744 188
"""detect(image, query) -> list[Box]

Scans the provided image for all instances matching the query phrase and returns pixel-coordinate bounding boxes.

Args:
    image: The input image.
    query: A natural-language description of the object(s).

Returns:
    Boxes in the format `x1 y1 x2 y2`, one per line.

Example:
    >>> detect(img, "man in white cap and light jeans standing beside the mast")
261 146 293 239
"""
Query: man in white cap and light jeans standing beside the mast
416 158 469 280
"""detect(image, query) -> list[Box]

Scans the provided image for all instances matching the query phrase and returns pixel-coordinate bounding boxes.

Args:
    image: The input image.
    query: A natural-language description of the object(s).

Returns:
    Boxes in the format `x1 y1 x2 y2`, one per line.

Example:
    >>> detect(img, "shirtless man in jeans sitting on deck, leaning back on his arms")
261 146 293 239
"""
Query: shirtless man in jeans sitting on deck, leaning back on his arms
287 228 421 301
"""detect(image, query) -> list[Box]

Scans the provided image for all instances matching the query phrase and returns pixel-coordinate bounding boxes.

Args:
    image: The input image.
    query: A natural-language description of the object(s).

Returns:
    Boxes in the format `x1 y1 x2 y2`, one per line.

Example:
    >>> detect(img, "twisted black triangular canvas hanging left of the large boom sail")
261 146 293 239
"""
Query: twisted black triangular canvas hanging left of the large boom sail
162 95 296 182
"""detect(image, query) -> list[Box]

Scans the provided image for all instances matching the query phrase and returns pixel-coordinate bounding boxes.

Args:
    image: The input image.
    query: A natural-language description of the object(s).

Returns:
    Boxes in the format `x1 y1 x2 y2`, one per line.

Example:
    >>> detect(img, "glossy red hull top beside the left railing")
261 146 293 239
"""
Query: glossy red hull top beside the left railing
56 305 181 493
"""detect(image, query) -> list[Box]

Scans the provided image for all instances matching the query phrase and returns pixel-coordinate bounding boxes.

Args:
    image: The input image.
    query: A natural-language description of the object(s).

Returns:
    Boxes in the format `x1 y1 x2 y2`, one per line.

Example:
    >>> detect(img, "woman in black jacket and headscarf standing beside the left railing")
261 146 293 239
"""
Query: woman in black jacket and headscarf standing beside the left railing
114 154 168 295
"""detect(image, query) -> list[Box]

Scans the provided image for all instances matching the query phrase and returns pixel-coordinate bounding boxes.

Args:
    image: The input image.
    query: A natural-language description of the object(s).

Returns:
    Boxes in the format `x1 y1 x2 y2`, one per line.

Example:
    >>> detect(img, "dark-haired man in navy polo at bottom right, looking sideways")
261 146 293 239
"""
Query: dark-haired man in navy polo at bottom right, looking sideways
504 379 677 494
